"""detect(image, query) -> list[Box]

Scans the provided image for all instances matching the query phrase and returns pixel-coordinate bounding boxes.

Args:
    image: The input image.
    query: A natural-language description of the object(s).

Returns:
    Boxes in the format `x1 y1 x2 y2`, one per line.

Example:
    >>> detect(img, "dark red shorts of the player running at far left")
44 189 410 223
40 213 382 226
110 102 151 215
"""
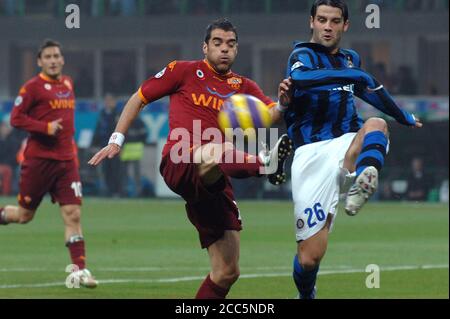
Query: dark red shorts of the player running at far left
18 158 82 210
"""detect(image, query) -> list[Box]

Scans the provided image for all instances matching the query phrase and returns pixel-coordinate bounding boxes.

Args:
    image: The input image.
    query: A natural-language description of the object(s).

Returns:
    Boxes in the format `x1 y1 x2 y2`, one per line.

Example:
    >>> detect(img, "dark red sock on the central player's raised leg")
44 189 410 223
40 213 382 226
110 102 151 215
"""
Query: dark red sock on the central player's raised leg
220 150 263 178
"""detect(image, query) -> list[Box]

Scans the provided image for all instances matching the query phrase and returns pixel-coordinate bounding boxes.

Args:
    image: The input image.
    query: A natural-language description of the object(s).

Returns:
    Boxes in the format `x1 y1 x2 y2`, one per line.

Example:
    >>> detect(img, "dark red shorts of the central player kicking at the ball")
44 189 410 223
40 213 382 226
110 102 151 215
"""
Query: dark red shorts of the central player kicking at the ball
159 155 242 248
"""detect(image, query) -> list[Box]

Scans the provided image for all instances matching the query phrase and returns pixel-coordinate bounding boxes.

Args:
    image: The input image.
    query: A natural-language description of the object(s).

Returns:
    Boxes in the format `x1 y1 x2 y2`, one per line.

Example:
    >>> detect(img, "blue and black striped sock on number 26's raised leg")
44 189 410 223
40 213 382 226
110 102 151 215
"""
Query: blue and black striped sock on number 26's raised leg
356 131 388 176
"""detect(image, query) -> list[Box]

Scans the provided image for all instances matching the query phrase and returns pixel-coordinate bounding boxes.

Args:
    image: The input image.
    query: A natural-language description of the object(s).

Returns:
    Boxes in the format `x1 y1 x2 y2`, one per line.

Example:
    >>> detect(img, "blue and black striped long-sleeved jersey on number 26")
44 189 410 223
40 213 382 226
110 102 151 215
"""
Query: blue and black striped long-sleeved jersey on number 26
284 42 415 148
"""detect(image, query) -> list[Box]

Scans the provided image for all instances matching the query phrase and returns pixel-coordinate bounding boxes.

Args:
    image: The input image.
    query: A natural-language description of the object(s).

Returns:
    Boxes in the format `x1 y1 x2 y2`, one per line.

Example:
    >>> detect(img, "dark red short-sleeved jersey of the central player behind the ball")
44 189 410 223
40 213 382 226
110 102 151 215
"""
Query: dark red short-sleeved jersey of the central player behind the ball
138 60 276 156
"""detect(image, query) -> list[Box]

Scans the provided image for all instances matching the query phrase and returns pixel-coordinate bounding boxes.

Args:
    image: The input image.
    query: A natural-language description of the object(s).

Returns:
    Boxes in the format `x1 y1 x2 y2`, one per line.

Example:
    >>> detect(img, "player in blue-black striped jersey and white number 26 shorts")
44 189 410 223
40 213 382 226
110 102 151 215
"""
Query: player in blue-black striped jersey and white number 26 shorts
279 0 422 299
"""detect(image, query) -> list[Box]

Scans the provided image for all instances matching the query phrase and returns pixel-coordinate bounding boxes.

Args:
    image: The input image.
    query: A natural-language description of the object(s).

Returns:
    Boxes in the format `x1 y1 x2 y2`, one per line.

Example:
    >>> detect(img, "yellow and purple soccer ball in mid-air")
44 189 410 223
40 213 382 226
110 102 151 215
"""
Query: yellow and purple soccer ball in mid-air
218 94 272 139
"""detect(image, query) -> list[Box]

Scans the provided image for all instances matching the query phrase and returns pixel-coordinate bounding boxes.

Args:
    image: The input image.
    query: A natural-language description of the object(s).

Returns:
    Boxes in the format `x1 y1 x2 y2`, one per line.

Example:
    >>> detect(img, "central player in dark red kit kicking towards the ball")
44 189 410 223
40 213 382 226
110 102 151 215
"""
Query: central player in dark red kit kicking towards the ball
89 19 290 299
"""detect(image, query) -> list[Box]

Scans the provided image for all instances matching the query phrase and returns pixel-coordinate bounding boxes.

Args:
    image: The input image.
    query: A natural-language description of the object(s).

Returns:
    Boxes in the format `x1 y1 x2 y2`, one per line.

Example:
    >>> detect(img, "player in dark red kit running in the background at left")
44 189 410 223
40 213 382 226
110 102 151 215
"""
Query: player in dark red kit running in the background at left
0 40 97 288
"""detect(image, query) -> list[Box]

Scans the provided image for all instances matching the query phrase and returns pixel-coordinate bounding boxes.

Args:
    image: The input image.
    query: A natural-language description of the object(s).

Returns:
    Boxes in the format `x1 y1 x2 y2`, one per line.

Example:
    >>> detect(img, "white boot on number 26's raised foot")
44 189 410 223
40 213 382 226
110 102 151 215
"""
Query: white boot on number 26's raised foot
345 166 378 216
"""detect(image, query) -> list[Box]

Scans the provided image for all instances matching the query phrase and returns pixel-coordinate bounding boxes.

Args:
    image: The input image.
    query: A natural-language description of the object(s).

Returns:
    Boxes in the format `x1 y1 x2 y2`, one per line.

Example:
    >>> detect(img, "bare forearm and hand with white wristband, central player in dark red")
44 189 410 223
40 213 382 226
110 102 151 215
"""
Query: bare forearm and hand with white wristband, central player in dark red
88 92 144 166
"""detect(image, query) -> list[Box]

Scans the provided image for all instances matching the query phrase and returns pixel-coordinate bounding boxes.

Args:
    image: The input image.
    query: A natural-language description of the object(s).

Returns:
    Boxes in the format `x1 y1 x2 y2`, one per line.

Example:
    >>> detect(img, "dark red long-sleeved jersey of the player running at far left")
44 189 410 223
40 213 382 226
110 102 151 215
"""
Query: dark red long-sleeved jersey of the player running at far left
11 73 75 161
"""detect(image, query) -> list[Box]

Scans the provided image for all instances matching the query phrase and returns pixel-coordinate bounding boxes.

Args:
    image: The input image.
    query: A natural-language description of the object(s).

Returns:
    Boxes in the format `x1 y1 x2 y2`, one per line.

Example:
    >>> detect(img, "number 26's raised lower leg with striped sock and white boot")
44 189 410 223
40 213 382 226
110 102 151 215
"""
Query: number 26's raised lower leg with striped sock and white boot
345 119 389 216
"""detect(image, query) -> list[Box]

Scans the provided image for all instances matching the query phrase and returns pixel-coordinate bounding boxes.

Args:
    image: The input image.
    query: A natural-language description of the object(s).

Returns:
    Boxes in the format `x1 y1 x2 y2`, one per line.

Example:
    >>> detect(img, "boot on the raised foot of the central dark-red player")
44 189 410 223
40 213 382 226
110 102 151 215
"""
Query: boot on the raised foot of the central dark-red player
259 134 292 185
